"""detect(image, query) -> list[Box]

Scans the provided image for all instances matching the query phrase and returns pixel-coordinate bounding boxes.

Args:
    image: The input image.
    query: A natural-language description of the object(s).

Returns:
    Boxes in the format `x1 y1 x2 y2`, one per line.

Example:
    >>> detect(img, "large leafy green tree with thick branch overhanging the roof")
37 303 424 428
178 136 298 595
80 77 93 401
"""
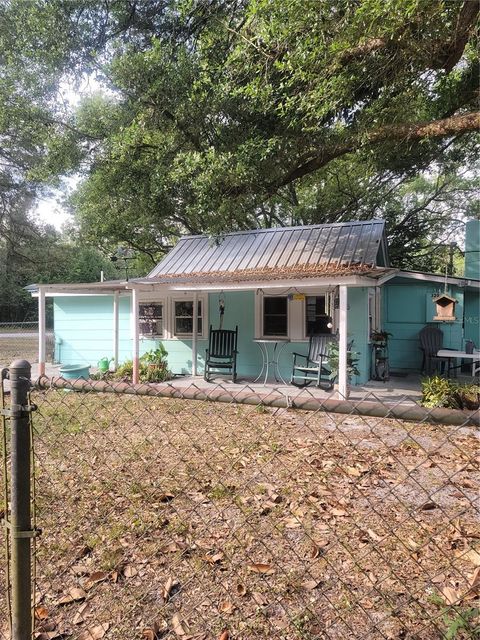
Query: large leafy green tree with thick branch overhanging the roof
0 0 480 268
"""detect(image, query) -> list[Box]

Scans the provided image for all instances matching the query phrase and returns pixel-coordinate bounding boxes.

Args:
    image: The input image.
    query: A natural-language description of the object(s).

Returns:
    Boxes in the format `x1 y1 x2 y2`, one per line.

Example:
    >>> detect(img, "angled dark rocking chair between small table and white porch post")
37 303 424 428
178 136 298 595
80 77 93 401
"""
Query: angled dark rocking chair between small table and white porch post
290 333 337 390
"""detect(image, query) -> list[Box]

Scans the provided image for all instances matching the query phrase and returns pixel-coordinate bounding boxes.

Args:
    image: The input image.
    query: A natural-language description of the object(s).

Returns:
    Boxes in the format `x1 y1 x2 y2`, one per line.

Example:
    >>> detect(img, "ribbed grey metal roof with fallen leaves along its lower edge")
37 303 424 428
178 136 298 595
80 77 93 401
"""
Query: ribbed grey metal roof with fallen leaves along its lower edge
147 220 388 278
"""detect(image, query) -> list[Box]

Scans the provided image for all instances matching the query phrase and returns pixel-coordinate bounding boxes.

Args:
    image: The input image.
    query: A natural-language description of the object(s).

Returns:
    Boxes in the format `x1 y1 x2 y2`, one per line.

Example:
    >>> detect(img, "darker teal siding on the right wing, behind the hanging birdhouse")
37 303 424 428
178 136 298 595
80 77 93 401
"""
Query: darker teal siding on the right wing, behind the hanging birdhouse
382 279 464 371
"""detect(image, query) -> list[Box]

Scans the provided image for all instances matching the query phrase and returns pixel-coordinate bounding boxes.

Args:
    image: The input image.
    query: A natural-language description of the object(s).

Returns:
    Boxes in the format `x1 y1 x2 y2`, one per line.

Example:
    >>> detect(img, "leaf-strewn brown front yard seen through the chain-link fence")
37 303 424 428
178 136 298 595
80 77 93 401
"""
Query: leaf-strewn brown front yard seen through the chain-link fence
0 379 480 640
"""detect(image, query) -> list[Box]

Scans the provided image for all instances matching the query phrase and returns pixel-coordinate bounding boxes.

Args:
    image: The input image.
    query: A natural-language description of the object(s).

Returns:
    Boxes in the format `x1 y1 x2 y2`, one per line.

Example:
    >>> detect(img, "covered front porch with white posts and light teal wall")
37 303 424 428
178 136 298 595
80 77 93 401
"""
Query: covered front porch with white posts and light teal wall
38 274 390 397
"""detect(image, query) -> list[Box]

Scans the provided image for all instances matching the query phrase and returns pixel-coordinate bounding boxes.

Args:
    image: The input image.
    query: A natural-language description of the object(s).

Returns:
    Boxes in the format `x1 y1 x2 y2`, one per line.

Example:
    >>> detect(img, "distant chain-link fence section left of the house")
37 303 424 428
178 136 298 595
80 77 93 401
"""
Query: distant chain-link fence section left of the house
0 322 55 367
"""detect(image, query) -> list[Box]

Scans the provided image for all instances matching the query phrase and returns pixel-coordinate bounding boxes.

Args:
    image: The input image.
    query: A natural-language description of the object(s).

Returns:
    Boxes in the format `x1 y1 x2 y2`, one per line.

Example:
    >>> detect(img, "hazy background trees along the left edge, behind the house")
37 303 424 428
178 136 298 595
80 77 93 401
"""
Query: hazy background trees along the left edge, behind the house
0 2 123 322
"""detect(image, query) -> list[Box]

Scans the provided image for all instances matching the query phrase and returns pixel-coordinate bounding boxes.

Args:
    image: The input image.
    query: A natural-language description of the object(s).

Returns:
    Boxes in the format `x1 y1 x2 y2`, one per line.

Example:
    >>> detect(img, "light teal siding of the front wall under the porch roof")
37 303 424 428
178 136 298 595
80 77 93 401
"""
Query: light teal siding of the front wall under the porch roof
54 288 369 383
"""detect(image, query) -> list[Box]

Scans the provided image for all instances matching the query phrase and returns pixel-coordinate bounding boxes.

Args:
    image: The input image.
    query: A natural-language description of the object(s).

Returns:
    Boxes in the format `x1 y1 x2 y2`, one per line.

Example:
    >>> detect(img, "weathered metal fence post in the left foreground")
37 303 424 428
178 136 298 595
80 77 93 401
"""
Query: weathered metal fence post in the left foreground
9 360 33 640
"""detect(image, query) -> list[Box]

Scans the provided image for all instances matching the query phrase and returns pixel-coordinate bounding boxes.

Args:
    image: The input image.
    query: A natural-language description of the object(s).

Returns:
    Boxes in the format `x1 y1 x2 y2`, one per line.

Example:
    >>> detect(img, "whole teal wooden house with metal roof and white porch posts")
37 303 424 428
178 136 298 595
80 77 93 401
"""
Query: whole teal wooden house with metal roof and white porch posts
31 220 480 392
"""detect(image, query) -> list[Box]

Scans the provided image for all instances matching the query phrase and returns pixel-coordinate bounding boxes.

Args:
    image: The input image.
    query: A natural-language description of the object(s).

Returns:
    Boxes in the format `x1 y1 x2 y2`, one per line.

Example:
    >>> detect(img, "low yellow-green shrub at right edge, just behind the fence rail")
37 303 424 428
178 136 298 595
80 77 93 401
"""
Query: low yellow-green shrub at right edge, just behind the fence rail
421 376 480 411
